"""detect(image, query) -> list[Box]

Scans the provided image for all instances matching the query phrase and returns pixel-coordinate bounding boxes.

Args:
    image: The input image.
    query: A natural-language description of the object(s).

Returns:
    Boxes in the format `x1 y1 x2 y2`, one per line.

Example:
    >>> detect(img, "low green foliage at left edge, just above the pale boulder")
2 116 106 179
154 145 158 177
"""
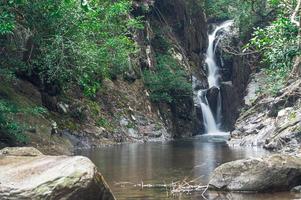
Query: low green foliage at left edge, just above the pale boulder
0 100 28 143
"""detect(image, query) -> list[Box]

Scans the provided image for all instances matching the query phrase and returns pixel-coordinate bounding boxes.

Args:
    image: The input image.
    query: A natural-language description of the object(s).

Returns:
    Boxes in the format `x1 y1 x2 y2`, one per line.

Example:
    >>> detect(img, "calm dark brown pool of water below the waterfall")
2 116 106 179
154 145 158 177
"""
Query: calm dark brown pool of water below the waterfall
79 137 301 200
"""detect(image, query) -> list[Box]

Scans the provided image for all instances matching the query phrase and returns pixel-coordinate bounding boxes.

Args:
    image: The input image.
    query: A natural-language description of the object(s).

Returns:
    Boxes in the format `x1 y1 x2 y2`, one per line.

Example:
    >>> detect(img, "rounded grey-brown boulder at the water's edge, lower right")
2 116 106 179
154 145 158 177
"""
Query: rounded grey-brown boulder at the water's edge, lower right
209 154 301 192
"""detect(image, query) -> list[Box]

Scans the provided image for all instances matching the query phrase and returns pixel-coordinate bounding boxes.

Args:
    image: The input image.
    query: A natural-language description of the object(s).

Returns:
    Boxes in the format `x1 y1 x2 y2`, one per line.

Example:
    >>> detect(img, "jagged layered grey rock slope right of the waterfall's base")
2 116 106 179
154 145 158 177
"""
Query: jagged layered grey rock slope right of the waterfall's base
229 74 301 153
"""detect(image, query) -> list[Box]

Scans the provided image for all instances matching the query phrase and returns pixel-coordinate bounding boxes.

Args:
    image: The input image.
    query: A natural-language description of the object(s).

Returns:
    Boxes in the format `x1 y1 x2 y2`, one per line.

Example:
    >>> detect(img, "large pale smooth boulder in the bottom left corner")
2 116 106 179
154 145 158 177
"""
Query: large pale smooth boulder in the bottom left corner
0 148 115 200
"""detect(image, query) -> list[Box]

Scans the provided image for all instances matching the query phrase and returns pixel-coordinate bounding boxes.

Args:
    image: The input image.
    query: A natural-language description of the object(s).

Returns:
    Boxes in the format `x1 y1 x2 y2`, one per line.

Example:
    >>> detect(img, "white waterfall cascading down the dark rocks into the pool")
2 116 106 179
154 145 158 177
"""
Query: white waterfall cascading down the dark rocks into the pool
197 20 233 134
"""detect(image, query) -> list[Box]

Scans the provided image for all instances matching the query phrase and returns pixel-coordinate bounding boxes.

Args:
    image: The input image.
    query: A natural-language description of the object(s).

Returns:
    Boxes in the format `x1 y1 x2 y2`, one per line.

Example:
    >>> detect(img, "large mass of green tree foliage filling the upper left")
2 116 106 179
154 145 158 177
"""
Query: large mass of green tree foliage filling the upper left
0 0 142 96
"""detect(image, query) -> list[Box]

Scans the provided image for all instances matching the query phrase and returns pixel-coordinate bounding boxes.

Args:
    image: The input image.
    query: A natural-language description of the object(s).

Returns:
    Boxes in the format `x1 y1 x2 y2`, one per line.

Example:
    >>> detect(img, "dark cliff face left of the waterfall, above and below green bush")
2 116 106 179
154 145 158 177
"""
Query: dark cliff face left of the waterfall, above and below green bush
136 0 208 138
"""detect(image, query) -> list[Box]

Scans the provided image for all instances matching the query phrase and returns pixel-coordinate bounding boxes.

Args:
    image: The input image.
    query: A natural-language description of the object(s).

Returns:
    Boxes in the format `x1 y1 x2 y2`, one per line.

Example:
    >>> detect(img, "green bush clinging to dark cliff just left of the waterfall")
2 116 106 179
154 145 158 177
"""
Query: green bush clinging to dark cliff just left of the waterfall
144 54 192 103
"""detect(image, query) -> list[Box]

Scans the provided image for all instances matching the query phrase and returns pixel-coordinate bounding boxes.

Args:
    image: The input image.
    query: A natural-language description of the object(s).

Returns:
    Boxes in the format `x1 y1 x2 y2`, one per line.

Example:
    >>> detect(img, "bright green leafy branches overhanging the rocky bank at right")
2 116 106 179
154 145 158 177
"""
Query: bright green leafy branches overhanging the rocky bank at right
246 14 300 96
